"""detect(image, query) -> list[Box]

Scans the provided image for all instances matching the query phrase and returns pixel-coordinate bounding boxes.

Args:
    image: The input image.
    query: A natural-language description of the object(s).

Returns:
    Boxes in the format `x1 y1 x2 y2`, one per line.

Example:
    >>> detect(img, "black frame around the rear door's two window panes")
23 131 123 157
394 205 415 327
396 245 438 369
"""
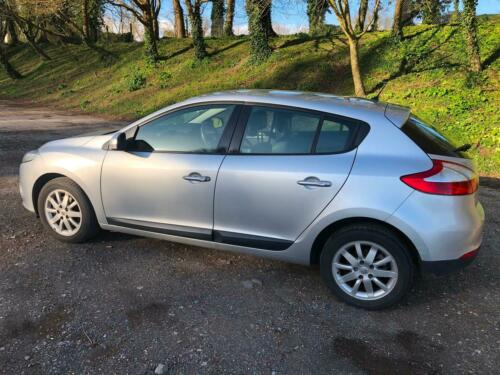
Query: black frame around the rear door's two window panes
228 102 370 156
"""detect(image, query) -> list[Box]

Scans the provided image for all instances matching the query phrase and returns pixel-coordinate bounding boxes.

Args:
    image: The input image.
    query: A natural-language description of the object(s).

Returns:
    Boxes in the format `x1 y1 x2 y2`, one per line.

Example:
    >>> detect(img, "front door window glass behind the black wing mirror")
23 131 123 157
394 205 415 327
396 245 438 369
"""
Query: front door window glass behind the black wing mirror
133 104 235 153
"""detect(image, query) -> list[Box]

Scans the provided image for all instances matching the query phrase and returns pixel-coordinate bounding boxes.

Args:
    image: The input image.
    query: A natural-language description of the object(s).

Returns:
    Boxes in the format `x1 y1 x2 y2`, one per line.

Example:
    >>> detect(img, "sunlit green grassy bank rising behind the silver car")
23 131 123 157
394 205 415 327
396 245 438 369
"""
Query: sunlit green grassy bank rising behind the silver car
0 15 500 176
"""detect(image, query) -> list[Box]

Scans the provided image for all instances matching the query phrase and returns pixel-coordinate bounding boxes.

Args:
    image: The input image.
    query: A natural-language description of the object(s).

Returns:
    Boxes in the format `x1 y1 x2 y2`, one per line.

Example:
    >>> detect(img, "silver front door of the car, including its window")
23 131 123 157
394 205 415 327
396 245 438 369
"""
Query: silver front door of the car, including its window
101 104 235 240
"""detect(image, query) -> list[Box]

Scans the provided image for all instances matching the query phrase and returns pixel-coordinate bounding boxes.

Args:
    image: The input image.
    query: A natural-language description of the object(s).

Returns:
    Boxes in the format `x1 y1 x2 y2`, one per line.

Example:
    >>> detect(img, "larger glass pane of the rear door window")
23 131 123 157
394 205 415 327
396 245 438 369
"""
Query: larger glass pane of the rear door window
240 107 321 154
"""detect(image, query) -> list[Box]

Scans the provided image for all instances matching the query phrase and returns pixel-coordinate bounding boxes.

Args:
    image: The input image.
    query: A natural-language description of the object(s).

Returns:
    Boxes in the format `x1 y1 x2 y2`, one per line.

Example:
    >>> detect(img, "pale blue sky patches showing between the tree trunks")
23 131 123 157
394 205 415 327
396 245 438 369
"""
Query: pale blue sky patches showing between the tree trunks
146 0 500 34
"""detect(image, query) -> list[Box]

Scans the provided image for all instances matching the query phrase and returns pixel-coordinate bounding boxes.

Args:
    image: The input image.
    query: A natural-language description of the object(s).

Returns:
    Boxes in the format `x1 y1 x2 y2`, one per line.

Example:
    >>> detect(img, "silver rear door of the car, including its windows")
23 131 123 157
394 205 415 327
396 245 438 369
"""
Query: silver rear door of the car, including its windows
214 106 360 250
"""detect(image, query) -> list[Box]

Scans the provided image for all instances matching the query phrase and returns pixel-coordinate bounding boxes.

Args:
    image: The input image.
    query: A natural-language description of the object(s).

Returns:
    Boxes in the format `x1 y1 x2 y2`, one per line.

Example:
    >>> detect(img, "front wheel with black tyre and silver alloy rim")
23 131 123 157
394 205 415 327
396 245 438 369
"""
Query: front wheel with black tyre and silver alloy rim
37 177 100 243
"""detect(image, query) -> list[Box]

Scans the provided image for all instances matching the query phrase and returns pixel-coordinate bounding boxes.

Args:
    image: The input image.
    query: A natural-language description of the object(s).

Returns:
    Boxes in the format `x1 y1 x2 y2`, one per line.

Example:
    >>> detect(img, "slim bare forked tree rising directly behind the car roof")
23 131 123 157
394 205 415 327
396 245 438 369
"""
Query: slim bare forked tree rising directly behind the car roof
328 0 380 96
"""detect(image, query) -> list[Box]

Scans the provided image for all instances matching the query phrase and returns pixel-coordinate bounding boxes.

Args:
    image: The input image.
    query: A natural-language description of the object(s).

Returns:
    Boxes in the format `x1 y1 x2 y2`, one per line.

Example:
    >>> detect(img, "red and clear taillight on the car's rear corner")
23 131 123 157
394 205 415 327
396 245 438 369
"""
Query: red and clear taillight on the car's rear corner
401 160 479 195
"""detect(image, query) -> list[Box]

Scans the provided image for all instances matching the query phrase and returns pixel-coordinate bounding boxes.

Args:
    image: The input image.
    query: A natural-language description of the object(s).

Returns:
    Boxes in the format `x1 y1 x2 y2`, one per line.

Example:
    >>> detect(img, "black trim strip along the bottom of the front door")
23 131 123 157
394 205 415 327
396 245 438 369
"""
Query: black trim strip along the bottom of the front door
107 217 212 241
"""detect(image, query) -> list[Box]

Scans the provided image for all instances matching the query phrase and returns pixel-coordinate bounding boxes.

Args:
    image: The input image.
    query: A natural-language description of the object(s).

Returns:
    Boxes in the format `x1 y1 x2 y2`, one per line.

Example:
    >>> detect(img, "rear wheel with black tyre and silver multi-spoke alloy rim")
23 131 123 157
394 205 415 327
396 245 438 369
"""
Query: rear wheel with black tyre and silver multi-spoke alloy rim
320 223 415 310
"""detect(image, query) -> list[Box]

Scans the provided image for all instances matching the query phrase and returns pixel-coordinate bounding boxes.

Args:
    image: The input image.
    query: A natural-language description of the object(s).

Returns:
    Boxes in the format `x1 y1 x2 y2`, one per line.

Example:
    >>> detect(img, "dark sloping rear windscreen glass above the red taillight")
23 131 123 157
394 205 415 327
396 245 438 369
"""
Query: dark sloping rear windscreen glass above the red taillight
401 116 467 158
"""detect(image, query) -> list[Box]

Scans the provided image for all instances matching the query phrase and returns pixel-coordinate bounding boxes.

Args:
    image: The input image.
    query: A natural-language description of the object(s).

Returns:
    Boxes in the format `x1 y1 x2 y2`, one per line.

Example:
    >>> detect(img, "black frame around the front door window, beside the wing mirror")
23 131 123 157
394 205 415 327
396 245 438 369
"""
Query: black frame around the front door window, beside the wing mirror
125 101 242 155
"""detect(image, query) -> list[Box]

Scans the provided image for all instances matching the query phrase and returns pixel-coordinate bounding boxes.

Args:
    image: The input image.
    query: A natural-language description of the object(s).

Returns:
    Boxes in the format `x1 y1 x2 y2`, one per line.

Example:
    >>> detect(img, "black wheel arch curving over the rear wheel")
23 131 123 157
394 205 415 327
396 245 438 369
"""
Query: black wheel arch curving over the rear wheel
310 217 421 267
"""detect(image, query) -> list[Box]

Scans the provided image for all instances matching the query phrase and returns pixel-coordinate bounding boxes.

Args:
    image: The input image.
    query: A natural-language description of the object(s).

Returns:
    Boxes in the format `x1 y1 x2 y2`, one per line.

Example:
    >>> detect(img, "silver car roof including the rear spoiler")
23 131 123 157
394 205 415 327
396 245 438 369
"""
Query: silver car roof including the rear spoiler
180 89 410 126
